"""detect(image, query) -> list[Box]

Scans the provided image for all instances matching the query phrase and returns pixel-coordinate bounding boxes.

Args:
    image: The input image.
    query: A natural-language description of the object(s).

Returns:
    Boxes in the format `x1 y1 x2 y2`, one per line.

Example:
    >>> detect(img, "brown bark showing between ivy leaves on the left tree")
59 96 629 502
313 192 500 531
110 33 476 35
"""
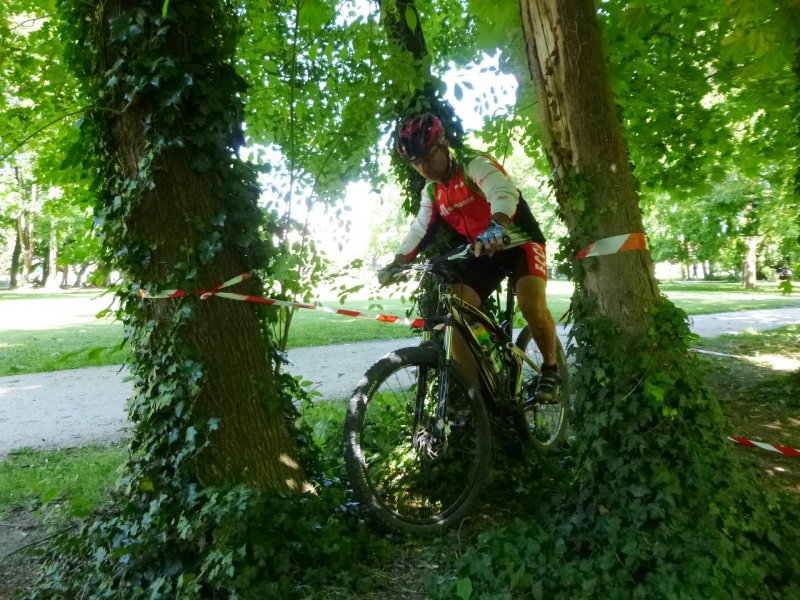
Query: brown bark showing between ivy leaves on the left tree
90 1 309 492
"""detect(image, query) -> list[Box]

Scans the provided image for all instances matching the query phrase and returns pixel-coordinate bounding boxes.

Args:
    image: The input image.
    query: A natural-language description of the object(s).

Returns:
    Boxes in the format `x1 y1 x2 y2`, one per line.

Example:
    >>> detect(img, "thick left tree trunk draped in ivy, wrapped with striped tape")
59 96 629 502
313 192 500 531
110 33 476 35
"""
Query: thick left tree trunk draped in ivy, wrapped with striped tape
65 0 308 492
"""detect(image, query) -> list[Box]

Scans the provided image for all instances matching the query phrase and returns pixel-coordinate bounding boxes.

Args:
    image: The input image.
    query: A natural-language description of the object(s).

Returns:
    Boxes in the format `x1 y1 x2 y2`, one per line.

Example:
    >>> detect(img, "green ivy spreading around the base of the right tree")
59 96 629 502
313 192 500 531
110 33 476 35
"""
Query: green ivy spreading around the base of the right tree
439 170 800 599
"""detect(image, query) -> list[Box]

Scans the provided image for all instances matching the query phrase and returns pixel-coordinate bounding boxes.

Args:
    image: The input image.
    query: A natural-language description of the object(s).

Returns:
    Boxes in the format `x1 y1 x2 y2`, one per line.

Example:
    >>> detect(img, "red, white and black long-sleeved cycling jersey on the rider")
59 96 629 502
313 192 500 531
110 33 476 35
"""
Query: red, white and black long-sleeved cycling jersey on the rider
397 153 544 260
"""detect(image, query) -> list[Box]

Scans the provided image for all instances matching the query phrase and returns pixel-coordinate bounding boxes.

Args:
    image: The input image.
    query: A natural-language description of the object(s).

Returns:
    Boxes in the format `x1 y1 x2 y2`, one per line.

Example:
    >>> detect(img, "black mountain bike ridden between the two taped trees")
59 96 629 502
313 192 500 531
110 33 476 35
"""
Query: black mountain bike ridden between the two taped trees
344 245 569 533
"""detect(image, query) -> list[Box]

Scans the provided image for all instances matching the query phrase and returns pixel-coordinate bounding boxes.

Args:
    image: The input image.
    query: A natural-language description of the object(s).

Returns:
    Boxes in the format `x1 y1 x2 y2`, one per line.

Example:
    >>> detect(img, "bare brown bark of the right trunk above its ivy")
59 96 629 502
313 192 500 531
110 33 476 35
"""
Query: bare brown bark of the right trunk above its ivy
520 0 659 335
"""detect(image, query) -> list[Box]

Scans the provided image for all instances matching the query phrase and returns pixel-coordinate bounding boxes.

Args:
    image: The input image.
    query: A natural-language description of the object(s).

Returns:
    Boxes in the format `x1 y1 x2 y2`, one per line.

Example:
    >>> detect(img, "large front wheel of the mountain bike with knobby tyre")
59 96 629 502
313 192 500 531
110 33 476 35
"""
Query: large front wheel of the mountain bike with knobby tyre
344 345 491 533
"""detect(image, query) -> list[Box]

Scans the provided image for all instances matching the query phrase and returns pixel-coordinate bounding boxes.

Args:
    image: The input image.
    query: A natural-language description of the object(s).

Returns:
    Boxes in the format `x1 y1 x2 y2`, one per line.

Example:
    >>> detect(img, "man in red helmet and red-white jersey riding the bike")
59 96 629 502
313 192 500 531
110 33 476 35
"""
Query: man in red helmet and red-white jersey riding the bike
378 113 561 402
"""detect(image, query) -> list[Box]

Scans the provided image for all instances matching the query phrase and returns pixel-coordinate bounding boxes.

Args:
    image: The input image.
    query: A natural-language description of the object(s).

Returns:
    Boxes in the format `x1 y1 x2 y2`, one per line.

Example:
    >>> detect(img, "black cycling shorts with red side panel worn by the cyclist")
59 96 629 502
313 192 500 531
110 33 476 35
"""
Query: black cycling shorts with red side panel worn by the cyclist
456 242 547 301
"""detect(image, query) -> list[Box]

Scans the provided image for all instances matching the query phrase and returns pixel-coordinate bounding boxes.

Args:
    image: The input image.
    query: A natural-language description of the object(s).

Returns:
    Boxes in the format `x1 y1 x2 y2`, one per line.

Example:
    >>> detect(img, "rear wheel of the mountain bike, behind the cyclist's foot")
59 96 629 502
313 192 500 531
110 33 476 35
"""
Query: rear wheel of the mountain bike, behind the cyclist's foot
516 326 570 452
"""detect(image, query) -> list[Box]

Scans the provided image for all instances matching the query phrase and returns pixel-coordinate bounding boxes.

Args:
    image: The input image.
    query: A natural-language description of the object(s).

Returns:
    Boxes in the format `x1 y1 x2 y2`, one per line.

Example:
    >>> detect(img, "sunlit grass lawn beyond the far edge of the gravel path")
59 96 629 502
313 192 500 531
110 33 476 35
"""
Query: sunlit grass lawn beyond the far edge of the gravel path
0 280 800 376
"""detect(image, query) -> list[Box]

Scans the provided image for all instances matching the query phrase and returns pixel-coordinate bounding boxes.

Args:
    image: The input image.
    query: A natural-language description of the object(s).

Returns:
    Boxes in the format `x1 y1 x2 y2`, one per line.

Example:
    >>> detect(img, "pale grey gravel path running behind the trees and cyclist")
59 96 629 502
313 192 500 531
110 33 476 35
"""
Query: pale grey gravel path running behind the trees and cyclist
0 308 800 457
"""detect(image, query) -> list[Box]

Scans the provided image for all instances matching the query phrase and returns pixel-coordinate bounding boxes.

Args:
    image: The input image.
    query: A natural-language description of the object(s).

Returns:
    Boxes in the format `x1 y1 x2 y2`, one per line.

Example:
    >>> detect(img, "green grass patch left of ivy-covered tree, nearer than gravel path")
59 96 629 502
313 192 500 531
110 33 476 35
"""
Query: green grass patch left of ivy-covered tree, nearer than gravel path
0 445 126 518
